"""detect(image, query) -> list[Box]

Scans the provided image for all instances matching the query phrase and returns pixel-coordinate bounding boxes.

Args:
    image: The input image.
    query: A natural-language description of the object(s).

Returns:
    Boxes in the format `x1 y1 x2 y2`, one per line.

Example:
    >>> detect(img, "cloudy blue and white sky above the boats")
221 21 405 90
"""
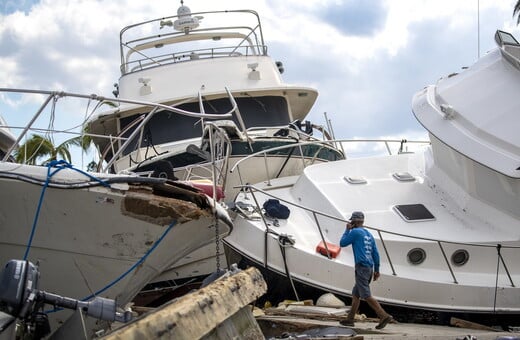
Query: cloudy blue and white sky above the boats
0 0 520 162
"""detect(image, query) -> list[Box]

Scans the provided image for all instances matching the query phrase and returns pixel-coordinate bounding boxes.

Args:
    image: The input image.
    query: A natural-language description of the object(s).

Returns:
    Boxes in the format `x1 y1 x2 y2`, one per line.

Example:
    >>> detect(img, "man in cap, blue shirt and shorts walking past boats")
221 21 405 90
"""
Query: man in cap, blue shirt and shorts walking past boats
339 211 393 329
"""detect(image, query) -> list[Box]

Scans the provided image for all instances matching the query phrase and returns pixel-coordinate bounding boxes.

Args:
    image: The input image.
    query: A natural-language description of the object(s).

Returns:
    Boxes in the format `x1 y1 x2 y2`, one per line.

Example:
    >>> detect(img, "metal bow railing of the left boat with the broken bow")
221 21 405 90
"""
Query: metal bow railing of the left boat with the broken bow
0 88 236 172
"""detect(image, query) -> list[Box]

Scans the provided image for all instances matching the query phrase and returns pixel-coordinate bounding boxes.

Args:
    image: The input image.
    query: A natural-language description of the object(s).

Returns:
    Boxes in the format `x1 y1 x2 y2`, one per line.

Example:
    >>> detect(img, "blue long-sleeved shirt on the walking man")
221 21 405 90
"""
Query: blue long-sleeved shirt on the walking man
339 227 379 272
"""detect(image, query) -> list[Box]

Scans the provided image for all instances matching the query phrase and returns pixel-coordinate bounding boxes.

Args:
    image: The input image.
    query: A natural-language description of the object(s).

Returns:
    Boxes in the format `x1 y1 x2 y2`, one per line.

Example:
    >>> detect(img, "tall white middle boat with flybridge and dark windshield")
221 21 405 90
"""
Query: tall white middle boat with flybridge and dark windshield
88 1 344 281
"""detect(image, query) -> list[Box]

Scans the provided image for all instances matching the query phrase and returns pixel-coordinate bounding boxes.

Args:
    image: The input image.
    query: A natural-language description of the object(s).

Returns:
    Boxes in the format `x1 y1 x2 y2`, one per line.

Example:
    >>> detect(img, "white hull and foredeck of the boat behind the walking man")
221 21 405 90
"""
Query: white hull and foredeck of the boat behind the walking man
224 151 520 313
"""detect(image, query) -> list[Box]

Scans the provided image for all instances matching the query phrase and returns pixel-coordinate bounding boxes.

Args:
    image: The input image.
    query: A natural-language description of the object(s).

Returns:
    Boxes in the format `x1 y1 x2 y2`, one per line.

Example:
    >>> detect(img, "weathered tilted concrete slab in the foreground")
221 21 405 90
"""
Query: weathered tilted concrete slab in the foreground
102 267 267 340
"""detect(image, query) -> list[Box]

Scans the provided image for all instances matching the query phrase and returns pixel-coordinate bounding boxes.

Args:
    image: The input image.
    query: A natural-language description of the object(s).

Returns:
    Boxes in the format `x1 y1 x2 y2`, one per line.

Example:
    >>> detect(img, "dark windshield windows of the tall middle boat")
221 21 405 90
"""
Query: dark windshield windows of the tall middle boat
121 96 290 155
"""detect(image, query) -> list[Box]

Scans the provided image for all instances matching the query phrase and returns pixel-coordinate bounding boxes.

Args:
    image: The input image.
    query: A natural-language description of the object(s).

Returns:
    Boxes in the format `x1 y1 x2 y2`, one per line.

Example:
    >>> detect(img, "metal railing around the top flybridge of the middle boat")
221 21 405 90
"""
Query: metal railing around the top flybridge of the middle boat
120 10 267 75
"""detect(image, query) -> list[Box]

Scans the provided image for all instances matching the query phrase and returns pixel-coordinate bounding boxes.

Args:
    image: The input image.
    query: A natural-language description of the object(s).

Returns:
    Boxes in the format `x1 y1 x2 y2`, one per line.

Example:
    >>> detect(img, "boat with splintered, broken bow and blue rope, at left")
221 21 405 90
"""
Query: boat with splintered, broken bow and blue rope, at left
0 89 232 334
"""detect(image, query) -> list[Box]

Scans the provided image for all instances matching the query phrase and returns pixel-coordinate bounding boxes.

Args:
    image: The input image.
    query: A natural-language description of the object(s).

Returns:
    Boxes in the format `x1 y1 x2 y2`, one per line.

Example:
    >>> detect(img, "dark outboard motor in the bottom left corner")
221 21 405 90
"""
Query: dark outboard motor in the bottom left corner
0 260 131 340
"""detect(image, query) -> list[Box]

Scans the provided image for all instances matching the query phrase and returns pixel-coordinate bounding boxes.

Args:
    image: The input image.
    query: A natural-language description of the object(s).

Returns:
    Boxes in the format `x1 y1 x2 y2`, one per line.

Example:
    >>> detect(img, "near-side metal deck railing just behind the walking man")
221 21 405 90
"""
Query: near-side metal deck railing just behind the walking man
239 184 520 294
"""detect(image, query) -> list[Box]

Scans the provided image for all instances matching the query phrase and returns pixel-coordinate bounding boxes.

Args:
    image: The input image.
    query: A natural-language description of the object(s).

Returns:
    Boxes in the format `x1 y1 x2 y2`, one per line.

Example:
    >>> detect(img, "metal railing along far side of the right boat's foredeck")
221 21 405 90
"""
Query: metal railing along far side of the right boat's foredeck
230 137 430 186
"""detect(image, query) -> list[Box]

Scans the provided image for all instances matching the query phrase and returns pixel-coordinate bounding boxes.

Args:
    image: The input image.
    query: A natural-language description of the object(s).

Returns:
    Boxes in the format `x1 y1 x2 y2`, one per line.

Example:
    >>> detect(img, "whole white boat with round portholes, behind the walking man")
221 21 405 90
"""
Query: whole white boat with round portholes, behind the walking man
225 31 520 314
